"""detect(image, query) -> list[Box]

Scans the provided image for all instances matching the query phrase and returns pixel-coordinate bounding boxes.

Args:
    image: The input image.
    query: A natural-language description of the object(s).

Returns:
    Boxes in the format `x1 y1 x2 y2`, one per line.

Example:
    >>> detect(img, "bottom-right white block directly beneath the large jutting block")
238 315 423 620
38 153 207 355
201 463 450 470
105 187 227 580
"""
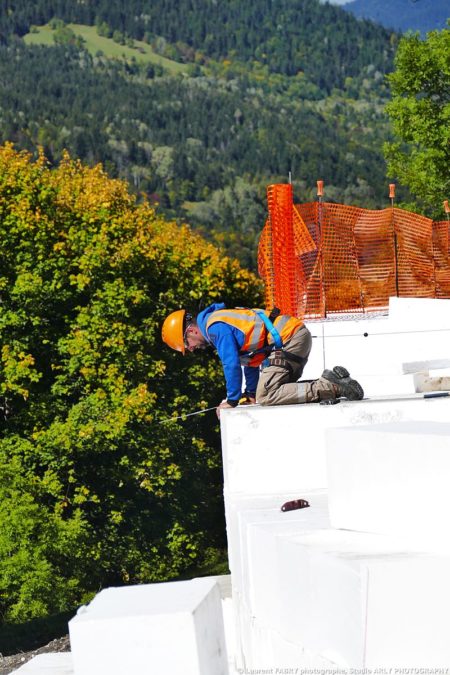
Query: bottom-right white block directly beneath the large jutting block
279 530 450 668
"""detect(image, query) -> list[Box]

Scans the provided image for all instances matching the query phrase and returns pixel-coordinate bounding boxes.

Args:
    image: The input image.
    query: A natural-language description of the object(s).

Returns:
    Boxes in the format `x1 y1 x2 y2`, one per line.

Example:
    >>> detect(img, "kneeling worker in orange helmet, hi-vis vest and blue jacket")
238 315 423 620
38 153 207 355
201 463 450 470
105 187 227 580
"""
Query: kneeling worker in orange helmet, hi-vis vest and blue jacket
162 303 364 414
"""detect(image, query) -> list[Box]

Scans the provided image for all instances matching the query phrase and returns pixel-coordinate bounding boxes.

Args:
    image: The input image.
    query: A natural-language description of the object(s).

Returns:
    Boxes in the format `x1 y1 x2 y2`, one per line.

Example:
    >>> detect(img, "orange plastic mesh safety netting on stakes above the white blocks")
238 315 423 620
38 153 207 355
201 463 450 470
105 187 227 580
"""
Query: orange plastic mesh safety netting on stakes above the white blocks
258 184 450 318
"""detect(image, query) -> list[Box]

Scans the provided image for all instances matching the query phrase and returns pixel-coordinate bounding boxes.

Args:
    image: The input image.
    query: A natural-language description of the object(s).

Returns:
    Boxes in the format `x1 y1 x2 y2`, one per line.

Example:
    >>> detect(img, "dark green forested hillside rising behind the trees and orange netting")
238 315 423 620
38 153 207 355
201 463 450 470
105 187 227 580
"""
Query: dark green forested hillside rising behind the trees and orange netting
0 0 397 267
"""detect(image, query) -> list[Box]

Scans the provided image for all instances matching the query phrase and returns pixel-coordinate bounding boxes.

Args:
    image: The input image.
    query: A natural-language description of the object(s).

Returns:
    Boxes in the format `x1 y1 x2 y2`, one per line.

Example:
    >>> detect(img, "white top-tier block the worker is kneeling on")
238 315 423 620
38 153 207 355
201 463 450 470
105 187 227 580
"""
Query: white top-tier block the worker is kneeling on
221 396 449 498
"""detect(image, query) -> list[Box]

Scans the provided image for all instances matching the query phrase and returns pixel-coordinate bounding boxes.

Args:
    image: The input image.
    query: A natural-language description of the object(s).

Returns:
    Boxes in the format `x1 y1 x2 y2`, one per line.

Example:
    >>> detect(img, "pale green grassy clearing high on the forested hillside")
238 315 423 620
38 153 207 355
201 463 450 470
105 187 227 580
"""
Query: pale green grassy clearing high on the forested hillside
23 23 187 75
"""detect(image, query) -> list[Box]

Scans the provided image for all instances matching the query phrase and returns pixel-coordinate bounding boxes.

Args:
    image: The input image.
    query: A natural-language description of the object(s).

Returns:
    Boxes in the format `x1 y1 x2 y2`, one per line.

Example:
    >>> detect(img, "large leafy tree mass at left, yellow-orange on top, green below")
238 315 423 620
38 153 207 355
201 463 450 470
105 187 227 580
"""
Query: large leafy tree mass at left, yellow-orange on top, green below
0 145 261 621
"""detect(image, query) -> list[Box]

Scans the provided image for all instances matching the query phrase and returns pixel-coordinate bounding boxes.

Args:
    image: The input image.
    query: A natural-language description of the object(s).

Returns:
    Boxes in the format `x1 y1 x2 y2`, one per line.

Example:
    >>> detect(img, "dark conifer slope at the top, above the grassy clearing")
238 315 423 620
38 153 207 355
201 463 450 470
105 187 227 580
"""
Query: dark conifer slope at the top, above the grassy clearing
0 0 392 91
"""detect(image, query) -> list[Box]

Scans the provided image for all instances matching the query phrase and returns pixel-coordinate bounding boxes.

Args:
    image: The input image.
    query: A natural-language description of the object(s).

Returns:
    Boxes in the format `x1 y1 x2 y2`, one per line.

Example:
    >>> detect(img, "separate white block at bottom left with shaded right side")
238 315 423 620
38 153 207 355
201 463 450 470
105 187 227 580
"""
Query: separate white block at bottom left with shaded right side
69 578 227 675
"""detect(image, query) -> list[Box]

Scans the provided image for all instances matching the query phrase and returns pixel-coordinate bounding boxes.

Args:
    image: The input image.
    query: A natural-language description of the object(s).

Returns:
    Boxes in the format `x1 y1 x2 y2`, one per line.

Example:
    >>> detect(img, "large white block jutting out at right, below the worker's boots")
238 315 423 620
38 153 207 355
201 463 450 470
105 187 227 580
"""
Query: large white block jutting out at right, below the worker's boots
327 420 450 550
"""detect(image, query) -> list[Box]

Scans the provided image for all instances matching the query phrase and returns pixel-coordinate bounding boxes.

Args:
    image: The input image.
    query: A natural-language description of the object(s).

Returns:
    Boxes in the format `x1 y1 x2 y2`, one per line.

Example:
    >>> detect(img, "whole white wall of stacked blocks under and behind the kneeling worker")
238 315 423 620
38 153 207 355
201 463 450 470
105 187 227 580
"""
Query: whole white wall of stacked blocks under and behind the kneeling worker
221 299 450 672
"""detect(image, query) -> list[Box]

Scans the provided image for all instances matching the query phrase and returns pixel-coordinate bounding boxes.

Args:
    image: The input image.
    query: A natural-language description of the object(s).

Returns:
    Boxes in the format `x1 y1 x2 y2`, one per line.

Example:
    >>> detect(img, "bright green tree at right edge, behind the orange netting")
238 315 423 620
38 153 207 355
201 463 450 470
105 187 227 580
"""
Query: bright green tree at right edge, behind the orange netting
385 28 450 217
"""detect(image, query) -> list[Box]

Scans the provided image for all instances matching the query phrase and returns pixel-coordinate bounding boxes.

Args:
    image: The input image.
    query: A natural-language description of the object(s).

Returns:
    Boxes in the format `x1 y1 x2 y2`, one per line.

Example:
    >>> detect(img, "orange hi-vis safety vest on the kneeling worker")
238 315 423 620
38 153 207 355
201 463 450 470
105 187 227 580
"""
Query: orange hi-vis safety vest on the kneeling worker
206 307 303 366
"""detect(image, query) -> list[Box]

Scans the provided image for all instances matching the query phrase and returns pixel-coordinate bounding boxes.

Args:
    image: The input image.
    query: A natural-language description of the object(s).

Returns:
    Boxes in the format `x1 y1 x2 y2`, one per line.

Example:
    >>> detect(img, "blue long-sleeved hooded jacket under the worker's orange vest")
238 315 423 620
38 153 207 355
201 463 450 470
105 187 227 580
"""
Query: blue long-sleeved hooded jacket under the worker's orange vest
197 302 259 401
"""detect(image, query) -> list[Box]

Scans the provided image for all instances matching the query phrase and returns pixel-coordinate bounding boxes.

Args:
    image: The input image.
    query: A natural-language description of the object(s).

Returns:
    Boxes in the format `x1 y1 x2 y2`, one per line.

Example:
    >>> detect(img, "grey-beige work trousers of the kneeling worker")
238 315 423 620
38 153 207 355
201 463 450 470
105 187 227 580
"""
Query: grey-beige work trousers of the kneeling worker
256 326 337 405
